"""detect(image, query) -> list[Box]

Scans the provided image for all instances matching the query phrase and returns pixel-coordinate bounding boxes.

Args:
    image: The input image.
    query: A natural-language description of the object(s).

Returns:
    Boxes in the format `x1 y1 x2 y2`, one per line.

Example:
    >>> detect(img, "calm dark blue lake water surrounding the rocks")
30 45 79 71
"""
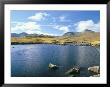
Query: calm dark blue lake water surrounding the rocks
11 44 100 77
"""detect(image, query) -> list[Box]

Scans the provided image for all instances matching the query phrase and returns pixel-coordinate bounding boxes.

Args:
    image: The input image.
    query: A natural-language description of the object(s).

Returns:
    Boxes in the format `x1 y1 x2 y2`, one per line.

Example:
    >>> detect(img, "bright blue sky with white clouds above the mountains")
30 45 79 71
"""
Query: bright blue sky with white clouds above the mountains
11 10 100 36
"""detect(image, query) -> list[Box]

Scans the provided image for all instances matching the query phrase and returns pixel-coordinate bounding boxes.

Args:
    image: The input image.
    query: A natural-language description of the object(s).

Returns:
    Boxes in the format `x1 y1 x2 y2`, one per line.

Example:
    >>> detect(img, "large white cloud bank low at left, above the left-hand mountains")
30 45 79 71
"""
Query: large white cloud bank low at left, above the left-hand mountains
11 21 57 36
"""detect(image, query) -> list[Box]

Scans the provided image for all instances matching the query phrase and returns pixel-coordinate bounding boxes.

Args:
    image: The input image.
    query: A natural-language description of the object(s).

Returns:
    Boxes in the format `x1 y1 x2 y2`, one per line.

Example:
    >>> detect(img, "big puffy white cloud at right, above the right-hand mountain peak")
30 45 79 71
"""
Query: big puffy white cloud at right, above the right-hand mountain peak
74 20 100 32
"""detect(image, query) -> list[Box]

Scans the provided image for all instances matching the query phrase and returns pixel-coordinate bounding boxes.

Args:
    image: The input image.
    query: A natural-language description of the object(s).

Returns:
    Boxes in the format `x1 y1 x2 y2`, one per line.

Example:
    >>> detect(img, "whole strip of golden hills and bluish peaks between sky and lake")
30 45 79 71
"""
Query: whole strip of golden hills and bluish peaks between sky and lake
11 30 100 46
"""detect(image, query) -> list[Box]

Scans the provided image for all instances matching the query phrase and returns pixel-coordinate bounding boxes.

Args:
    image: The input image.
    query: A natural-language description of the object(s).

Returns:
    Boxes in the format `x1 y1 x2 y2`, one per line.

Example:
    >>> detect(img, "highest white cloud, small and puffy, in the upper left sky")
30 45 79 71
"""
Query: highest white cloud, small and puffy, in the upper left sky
28 12 49 21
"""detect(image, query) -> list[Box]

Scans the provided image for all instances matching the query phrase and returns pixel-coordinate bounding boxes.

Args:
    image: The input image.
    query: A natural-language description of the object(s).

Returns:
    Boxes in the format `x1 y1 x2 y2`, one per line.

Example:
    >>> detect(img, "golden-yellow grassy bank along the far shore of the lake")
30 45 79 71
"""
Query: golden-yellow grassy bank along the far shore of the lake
11 37 100 46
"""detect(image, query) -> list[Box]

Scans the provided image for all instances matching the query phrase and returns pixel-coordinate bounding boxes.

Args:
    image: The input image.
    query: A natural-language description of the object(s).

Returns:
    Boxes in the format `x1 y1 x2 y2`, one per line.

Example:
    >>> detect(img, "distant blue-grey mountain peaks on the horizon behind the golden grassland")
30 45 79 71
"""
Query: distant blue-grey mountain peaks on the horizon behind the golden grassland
11 29 99 37
